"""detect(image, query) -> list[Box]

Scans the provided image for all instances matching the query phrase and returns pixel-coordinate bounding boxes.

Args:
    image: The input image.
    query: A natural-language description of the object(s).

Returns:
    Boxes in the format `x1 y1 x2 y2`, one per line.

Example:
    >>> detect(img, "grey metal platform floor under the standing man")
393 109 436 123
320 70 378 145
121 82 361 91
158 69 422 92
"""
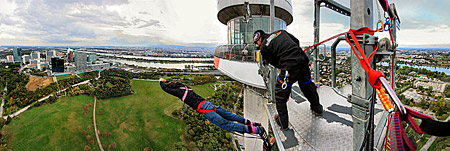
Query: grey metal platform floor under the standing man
266 85 384 151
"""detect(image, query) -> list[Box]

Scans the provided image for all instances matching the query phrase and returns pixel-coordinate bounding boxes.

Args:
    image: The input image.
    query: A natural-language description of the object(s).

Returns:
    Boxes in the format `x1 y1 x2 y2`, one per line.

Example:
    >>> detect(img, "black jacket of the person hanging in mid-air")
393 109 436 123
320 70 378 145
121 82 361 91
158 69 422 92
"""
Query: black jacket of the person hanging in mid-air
159 81 205 110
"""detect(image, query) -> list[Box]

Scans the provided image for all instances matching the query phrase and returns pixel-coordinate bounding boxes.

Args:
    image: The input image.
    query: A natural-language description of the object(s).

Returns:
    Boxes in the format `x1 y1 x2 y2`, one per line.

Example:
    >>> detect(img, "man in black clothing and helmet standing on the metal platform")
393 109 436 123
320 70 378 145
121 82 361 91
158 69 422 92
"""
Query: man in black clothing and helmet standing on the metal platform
253 30 323 129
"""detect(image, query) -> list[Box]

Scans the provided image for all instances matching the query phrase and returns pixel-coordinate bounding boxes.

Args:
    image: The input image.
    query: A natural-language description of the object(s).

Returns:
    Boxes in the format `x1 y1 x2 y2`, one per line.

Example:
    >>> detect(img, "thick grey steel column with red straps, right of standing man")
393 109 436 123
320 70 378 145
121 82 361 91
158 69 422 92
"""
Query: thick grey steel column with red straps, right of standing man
350 0 374 150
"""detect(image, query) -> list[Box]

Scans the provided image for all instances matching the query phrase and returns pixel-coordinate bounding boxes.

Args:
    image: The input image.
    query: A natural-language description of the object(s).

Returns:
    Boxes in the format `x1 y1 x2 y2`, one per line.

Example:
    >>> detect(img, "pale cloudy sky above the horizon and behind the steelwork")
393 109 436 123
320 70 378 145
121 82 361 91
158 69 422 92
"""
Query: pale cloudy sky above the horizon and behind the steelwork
0 0 450 47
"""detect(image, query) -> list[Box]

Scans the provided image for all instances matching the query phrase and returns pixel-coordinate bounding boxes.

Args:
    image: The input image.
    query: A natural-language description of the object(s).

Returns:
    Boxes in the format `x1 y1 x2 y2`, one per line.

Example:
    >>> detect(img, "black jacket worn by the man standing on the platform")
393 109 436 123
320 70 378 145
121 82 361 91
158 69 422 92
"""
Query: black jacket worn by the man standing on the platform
261 30 309 71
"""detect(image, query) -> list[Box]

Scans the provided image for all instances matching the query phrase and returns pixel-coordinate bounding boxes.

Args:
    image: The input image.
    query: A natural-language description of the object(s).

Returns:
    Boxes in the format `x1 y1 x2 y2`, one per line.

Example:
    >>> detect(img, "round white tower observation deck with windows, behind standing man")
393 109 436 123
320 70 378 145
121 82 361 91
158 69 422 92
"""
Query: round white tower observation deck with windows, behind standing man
214 0 293 89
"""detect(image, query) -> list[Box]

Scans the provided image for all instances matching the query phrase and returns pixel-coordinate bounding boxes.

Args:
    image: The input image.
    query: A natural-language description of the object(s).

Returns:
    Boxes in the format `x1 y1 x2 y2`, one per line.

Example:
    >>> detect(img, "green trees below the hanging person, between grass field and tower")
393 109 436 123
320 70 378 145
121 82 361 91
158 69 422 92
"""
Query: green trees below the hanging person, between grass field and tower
172 82 243 150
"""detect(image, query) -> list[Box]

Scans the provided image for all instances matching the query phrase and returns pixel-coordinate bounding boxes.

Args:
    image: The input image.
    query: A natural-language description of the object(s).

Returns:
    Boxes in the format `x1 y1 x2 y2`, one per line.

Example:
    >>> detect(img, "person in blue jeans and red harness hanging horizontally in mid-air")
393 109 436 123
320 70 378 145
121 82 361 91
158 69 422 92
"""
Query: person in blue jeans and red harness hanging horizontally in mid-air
159 78 268 145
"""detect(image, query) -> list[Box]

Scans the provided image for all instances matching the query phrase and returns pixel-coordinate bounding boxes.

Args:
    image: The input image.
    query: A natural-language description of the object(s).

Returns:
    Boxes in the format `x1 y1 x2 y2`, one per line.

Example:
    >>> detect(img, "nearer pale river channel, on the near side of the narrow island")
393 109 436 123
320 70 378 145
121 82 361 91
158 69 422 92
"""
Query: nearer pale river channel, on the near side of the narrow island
100 58 214 69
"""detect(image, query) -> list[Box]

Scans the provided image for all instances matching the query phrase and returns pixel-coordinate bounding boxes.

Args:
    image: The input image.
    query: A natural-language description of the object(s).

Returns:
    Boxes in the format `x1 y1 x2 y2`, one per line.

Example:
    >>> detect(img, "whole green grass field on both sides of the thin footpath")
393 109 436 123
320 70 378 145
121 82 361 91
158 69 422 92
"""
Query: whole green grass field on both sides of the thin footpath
9 80 213 150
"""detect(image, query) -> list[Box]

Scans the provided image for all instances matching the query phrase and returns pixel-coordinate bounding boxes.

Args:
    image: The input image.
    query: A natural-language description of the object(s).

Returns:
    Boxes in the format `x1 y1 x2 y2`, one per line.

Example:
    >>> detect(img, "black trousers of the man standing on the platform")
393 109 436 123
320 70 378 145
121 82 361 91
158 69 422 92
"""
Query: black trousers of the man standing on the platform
275 66 320 128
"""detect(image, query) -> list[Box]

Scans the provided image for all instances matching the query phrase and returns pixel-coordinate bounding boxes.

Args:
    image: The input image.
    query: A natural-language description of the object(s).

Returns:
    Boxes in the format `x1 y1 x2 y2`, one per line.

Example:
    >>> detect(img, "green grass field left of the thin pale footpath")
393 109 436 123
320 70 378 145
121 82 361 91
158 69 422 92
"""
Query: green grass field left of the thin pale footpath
8 96 99 150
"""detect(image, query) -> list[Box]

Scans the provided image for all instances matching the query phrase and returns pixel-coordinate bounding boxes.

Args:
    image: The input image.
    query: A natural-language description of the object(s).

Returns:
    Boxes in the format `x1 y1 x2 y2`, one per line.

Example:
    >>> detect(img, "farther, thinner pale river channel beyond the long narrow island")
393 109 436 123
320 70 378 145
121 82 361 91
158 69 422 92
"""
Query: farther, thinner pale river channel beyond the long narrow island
97 53 214 61
